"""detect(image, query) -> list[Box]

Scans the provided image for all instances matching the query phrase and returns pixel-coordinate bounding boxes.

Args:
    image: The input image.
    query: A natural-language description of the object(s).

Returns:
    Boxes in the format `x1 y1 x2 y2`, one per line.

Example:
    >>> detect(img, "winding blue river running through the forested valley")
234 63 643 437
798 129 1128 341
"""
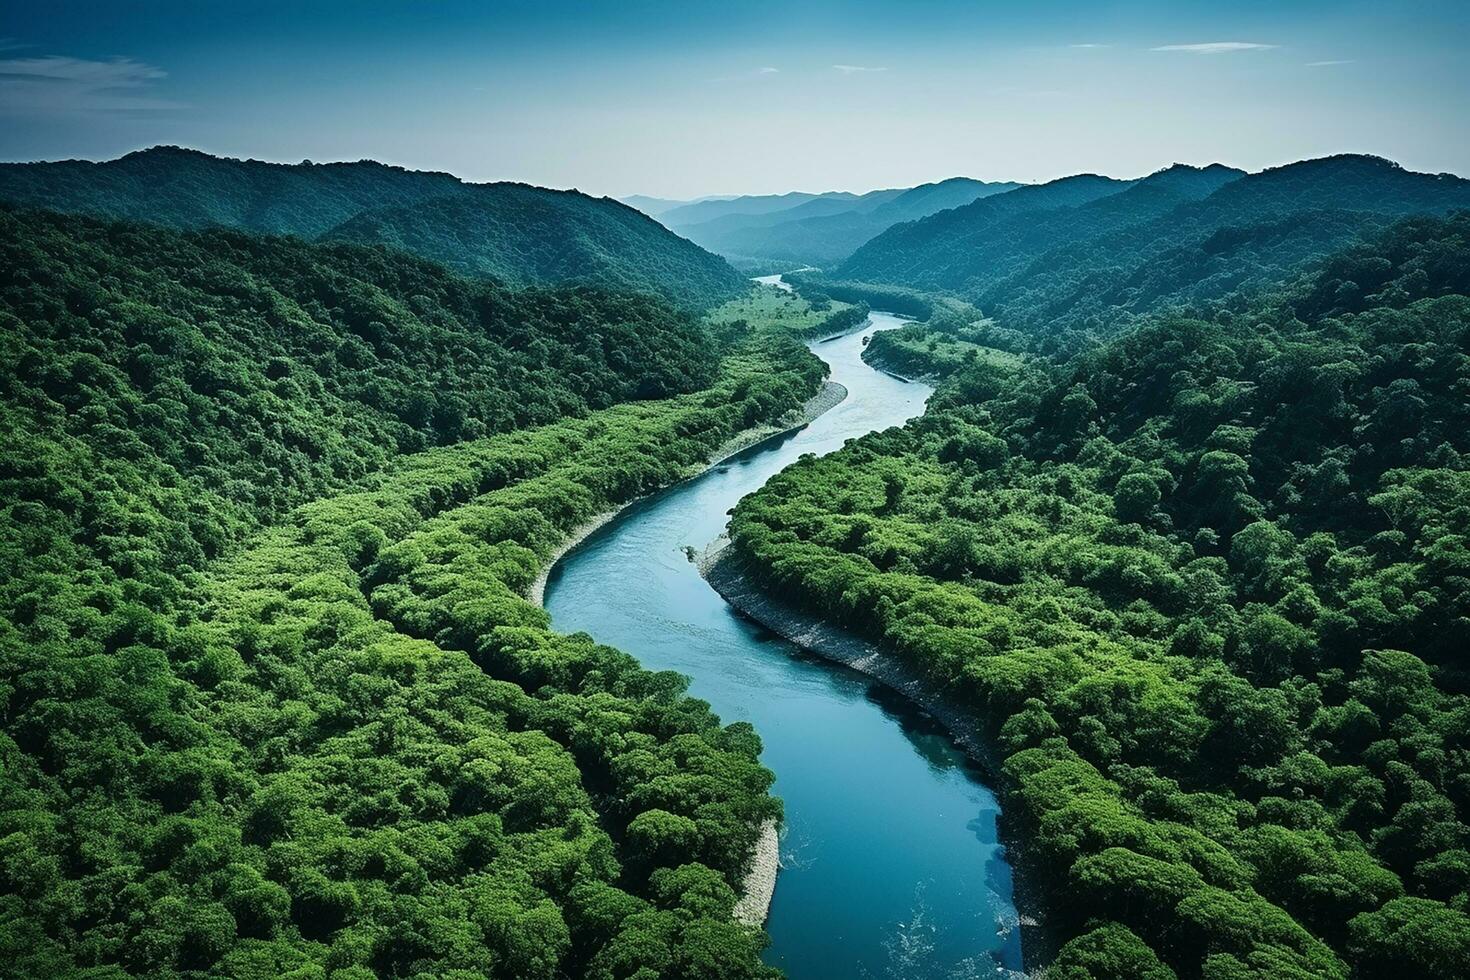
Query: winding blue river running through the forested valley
545 276 1022 980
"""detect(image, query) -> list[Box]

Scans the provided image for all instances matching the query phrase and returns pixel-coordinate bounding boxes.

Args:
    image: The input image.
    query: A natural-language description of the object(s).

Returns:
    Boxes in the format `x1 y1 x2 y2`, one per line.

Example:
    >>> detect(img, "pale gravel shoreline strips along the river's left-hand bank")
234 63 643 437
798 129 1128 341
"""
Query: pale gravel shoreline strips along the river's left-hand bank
526 381 847 929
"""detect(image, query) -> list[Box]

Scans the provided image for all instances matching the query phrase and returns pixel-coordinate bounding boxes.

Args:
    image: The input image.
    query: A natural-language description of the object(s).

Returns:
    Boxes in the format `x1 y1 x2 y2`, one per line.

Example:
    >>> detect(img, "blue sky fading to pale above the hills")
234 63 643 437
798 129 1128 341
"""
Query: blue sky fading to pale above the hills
0 0 1470 198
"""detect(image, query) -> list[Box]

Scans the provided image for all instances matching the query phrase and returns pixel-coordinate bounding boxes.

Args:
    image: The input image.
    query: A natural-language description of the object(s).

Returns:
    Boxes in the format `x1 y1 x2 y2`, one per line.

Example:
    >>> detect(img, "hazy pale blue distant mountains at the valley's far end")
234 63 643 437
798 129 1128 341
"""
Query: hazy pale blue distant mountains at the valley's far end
660 178 1020 266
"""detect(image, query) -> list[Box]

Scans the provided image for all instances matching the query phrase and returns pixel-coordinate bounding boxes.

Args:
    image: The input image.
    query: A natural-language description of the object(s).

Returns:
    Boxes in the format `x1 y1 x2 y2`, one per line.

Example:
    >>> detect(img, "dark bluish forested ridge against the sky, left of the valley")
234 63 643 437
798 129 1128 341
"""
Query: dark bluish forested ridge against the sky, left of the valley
0 147 744 309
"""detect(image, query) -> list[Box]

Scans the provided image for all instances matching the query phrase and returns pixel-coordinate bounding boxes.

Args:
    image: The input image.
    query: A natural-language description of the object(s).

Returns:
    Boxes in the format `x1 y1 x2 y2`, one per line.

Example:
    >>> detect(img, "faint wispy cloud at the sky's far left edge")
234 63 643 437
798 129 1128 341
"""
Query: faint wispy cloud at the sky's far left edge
0 54 184 115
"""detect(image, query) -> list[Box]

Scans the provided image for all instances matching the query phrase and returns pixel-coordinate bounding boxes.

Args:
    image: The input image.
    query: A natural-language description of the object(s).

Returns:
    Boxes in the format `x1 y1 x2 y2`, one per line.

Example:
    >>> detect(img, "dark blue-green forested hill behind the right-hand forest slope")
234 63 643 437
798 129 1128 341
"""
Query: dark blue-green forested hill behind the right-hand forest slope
833 156 1470 345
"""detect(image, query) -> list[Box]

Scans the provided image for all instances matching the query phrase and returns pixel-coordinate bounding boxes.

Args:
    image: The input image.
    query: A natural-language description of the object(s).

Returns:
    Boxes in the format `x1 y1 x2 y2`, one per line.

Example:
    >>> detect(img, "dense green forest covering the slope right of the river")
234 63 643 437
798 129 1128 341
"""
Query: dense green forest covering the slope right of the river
731 213 1470 980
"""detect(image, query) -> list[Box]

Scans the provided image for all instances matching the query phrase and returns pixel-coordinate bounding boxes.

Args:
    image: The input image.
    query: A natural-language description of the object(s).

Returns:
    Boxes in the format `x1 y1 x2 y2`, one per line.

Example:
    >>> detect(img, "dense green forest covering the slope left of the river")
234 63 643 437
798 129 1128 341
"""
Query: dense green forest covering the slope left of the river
0 210 822 980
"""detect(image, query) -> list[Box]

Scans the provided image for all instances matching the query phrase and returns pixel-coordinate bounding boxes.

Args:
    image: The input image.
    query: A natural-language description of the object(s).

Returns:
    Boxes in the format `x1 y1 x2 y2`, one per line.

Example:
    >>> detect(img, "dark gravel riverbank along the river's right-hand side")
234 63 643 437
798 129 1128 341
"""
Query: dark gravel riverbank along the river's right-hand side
698 535 1055 973
